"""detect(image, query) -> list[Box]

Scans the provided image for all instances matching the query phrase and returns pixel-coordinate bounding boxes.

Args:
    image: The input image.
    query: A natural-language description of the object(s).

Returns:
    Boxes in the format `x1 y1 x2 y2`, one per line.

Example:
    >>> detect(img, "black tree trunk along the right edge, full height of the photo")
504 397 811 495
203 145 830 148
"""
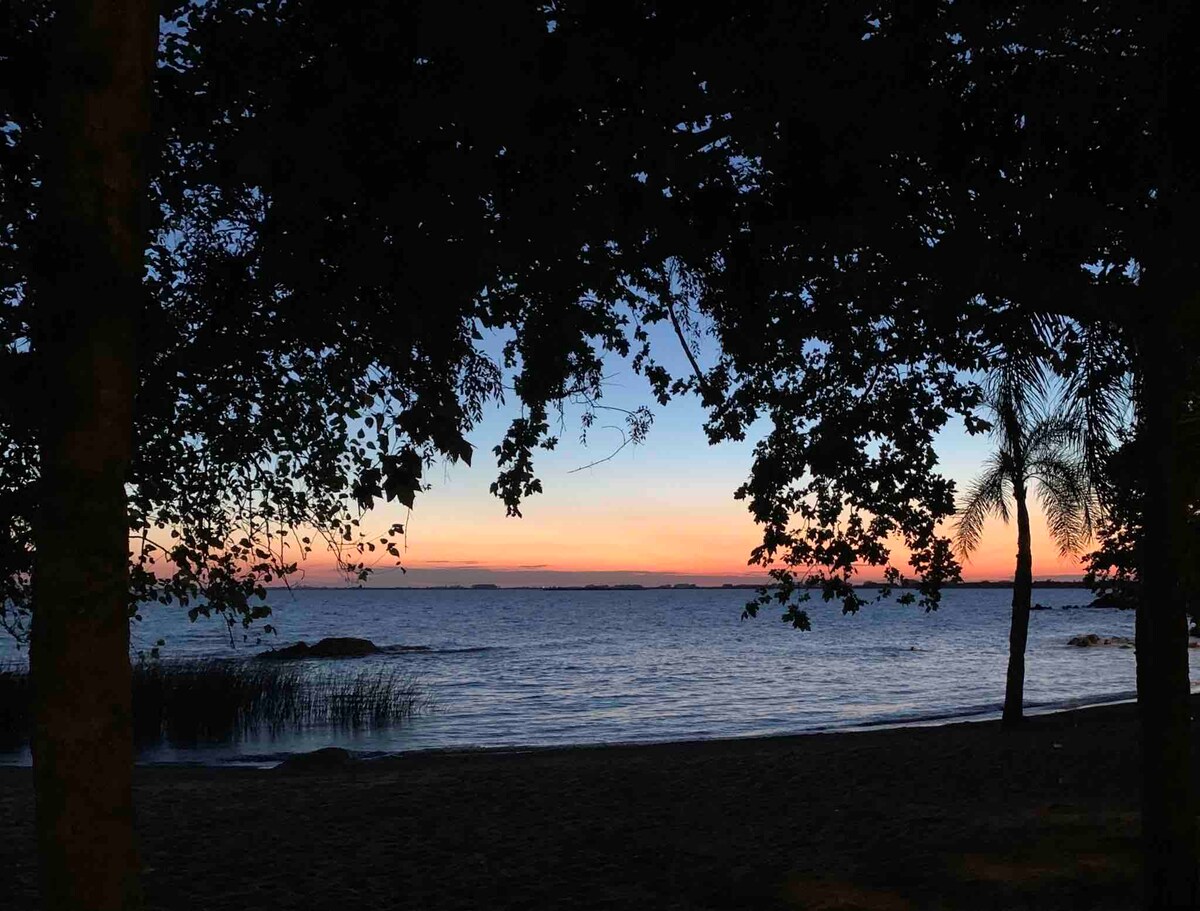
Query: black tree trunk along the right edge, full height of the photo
1130 0 1200 909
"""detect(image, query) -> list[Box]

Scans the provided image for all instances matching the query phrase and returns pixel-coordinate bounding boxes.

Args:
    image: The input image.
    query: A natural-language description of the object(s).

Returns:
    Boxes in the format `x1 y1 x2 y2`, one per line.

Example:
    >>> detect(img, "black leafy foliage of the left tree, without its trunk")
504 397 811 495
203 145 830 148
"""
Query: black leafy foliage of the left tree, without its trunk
0 2 686 631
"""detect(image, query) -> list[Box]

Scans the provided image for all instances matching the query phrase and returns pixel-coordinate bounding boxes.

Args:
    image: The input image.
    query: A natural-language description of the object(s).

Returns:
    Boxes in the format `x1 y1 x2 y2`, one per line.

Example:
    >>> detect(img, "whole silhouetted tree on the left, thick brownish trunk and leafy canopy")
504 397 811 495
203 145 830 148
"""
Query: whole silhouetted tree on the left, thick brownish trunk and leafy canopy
0 0 686 909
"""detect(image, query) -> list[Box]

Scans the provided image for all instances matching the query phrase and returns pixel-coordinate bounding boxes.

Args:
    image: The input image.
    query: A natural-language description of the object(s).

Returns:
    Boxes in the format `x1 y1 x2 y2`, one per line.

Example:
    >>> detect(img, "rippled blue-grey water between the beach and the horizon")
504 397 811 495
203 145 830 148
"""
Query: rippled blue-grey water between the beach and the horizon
0 588 1171 763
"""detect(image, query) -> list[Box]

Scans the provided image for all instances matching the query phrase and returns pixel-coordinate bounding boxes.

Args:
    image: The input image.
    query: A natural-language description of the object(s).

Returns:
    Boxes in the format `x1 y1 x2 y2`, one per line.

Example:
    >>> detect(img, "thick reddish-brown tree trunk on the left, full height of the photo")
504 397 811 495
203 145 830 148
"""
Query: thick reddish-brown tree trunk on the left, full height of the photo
30 0 158 911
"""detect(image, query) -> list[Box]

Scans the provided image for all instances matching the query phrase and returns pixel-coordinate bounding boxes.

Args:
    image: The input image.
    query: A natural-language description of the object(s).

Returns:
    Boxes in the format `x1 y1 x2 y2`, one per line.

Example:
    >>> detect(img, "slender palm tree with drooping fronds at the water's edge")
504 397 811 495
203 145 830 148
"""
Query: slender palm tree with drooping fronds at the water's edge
955 359 1093 725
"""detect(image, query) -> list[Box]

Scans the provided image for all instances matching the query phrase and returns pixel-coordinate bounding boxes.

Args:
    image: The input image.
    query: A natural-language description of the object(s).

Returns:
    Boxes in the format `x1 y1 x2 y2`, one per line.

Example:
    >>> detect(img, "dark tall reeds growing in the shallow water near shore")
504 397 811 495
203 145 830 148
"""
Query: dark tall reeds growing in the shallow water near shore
0 659 428 744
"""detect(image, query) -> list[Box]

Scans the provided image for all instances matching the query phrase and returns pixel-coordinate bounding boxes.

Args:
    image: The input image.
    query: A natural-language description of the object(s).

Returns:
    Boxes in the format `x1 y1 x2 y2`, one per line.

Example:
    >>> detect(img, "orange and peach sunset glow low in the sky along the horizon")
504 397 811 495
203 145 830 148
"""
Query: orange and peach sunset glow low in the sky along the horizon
290 491 1082 586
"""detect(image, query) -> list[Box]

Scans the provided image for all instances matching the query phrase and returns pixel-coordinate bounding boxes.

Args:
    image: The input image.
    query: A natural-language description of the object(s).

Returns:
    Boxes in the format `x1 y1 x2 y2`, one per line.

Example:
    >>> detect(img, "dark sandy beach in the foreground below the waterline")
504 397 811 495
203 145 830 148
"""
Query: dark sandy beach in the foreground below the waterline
0 706 1180 911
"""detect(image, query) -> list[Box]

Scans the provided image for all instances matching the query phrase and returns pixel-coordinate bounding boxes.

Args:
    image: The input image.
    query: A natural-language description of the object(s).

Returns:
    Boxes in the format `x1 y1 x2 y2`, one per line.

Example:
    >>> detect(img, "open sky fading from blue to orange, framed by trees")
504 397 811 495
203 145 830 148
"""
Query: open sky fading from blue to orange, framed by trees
290 321 1081 586
